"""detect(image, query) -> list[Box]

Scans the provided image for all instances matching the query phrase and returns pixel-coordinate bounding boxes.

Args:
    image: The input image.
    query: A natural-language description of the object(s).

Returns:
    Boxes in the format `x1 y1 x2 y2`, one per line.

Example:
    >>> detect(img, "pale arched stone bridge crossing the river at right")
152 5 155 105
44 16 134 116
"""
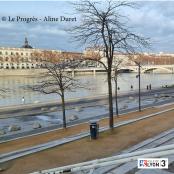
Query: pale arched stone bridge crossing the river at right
119 65 174 73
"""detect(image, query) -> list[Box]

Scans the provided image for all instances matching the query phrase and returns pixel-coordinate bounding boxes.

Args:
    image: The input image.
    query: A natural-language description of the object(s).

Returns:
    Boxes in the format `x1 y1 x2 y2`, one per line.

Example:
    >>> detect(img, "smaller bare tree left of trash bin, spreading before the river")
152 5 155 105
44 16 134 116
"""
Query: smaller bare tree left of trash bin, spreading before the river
28 52 80 128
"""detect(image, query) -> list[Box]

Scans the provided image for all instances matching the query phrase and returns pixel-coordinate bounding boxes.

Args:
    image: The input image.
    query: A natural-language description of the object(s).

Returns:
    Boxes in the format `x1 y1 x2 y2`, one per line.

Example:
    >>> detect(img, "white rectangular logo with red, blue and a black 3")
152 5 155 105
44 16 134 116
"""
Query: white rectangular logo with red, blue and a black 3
138 158 168 169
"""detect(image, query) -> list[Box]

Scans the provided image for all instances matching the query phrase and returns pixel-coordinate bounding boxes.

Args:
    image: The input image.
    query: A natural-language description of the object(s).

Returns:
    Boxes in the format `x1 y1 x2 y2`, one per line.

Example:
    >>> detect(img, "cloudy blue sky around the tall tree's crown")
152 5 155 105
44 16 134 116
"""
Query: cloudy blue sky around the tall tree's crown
0 1 174 53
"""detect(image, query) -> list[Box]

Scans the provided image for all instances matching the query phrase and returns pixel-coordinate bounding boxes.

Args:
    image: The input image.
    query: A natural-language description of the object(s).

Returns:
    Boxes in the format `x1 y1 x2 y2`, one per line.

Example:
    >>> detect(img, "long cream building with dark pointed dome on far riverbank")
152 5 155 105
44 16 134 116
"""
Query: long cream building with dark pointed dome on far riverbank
0 38 76 69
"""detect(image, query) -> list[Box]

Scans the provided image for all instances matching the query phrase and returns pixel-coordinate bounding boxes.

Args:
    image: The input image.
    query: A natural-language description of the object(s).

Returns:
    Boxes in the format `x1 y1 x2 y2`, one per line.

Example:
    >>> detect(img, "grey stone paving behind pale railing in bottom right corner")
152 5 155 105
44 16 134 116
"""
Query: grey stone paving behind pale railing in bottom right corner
93 129 174 174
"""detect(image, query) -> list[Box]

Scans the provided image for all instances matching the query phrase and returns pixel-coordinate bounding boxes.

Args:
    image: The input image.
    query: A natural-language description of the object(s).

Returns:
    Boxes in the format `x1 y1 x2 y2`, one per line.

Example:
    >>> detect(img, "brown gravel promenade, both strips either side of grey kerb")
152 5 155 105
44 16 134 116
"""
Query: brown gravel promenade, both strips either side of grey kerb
0 105 174 174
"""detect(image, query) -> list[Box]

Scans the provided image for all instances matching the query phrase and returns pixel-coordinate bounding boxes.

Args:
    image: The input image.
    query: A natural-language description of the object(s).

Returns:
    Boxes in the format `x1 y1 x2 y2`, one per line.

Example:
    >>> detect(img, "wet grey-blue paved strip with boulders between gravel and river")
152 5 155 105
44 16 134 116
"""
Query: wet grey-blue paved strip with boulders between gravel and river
0 89 174 142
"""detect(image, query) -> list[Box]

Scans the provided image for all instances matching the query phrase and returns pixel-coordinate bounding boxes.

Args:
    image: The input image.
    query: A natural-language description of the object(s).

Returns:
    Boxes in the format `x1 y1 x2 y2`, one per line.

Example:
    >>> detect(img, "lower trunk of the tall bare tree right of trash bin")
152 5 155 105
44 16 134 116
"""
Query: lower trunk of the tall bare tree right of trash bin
107 70 114 129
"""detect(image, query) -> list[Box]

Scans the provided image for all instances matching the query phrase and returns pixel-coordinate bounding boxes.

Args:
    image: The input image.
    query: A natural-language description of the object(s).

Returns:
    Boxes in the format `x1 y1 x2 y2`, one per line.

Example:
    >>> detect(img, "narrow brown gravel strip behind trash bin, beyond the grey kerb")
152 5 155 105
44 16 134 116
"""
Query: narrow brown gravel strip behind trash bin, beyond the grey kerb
0 102 174 153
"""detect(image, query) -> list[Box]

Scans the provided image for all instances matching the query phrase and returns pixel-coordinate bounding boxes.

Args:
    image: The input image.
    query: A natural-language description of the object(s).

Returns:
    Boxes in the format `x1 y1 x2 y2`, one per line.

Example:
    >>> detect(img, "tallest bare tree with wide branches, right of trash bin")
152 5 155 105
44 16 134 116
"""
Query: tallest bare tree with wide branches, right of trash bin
71 0 148 128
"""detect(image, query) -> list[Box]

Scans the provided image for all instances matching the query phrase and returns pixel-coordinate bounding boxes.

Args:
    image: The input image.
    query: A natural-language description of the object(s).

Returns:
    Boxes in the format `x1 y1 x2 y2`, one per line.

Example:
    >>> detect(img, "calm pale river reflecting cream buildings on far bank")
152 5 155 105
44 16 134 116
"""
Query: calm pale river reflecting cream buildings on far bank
0 73 174 106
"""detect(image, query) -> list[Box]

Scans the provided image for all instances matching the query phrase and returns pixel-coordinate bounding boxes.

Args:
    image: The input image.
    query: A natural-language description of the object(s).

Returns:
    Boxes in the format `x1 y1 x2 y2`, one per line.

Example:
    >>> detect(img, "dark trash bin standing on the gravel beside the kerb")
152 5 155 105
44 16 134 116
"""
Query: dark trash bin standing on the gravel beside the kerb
89 120 99 139
